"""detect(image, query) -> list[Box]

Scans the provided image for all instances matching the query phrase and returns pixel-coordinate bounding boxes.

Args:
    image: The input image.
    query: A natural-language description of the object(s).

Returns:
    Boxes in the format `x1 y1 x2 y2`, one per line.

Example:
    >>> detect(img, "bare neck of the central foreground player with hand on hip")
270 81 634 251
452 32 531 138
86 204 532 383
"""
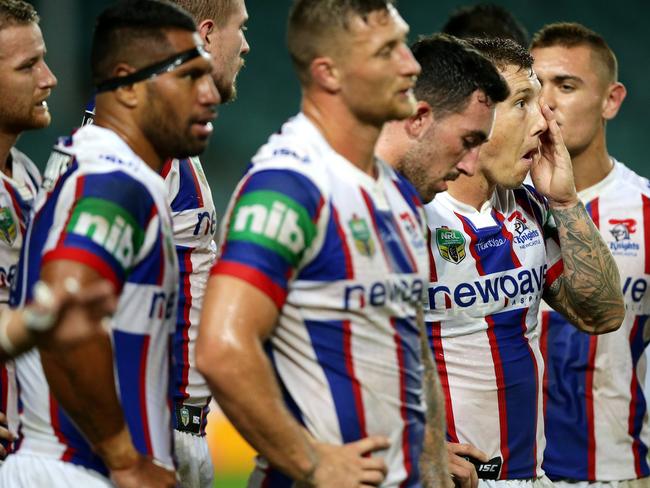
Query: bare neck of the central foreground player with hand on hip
302 92 381 176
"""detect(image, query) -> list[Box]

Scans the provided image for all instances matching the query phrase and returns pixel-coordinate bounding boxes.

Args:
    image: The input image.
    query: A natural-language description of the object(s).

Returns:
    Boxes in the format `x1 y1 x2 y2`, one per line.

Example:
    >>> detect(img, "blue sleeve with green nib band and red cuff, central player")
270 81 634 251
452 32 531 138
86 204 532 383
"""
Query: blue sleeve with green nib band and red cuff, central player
212 169 323 308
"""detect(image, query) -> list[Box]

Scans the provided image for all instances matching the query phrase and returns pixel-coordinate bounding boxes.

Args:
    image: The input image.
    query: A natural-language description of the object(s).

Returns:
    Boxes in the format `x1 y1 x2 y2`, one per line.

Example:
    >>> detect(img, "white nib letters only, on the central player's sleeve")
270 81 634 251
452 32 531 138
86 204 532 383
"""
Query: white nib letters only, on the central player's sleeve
232 201 305 253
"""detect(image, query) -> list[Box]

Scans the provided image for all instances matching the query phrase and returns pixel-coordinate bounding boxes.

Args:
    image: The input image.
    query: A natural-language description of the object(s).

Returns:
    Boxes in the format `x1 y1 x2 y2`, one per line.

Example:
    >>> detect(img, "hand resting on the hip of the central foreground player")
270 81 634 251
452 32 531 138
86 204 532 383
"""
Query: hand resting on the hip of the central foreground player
298 436 390 488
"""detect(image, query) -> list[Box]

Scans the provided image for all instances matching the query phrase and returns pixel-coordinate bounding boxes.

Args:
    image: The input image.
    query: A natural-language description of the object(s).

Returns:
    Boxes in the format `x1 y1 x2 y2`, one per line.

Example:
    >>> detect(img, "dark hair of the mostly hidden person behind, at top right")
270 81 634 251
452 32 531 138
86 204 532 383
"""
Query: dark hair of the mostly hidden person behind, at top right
442 3 528 47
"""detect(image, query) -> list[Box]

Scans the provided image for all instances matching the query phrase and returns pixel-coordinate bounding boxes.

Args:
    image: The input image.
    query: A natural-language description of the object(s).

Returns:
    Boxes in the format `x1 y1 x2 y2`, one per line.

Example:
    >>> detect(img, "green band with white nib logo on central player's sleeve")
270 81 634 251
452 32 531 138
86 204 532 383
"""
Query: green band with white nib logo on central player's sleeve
228 190 316 265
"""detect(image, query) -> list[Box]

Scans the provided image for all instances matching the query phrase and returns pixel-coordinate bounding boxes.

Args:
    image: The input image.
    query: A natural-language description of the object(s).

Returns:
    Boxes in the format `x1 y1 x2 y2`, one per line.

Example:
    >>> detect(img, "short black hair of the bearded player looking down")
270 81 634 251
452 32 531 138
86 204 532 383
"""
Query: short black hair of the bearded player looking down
411 34 509 117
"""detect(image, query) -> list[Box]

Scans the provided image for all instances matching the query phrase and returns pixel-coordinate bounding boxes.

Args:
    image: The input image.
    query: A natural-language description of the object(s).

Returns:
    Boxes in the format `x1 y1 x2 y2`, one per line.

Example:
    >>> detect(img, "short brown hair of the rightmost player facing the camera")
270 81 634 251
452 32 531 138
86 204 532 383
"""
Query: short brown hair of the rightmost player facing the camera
530 22 618 82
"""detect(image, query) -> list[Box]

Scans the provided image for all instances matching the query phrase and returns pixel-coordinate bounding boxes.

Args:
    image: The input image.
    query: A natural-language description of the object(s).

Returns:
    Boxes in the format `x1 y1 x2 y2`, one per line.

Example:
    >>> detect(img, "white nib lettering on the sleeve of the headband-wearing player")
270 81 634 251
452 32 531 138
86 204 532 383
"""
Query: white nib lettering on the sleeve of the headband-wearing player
72 212 134 268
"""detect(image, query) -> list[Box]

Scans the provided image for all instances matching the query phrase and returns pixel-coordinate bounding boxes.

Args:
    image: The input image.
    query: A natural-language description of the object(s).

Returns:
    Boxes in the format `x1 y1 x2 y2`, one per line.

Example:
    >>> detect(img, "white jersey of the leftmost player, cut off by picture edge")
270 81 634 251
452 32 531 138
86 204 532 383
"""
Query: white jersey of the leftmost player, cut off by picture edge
0 148 41 451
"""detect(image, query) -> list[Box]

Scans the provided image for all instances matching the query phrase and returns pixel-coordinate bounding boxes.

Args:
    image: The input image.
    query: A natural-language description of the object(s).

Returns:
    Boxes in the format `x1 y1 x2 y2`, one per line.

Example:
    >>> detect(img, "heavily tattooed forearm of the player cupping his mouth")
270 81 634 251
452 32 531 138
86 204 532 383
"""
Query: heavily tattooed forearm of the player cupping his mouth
544 203 625 334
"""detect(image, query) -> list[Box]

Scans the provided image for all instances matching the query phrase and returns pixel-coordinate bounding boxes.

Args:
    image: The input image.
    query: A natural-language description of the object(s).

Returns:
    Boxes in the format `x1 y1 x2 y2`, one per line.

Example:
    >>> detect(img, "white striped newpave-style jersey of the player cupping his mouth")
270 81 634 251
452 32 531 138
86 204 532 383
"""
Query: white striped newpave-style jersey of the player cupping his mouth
425 186 563 479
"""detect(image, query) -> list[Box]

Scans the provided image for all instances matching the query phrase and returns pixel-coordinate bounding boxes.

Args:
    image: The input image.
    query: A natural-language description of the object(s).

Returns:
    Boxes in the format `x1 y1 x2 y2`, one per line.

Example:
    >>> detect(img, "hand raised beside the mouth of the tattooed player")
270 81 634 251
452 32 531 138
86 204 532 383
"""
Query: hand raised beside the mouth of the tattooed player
530 101 579 208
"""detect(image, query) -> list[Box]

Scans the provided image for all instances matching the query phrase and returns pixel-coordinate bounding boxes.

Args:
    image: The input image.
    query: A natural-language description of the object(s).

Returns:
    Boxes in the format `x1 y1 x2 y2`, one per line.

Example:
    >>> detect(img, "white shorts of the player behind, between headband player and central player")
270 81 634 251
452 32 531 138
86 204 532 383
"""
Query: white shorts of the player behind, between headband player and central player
174 430 214 488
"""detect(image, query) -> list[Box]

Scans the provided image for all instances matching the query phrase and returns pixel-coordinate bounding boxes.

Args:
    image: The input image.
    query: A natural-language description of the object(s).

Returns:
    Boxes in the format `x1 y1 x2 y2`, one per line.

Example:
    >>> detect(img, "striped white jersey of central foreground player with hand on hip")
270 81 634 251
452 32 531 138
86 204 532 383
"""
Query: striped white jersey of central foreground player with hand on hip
213 114 428 488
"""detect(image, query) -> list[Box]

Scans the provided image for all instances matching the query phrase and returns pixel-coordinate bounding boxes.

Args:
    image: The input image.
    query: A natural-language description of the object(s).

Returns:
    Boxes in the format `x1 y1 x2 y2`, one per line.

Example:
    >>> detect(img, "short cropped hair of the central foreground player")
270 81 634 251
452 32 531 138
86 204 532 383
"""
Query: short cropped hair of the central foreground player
287 0 393 85
